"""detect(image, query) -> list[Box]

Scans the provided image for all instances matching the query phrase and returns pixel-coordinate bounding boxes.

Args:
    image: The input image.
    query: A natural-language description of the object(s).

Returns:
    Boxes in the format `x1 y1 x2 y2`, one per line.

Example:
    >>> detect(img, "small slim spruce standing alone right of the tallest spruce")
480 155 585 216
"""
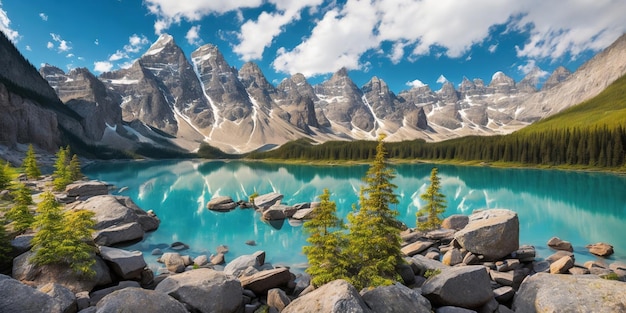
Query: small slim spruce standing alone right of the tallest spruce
417 167 446 230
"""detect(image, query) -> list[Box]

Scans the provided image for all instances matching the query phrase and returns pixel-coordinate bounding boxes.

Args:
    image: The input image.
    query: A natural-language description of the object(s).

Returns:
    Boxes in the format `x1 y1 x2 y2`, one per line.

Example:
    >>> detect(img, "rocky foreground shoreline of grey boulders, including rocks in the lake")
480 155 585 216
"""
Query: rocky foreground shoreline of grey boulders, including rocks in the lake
0 181 626 313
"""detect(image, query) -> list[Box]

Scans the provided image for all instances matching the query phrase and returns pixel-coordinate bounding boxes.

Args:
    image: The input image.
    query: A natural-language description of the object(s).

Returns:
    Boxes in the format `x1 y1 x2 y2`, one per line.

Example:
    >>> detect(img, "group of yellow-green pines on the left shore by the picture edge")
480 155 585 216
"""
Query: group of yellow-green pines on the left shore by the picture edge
0 145 95 276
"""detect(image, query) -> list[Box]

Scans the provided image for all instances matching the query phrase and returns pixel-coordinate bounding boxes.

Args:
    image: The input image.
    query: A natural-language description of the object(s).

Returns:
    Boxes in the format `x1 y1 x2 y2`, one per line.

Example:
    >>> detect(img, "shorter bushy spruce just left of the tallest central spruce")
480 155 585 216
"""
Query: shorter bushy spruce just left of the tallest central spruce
302 189 346 287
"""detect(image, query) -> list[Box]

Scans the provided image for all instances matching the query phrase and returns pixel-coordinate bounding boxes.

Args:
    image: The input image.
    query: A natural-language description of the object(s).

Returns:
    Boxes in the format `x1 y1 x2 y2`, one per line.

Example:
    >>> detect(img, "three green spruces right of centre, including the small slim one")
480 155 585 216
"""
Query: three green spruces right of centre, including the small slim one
303 136 445 290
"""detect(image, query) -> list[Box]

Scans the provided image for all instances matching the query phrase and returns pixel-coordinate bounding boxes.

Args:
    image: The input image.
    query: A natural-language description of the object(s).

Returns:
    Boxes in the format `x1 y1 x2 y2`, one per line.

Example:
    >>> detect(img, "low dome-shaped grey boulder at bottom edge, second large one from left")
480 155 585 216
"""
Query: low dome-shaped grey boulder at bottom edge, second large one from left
96 288 188 313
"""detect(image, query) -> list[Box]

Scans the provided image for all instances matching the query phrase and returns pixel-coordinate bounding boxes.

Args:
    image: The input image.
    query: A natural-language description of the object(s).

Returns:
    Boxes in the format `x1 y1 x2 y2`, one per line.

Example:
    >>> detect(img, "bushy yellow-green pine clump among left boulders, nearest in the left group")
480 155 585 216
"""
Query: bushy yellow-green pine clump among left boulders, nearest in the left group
31 191 95 276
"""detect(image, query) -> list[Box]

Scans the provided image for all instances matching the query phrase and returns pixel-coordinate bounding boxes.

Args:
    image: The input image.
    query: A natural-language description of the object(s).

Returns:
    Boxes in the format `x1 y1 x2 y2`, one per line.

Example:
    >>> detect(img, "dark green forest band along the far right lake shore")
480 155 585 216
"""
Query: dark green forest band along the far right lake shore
248 126 626 168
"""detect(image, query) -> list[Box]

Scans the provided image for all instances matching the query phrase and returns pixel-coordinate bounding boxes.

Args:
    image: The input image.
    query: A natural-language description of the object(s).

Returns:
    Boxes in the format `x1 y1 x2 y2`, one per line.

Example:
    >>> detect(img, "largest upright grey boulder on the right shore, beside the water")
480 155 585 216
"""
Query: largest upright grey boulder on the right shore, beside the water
454 209 519 260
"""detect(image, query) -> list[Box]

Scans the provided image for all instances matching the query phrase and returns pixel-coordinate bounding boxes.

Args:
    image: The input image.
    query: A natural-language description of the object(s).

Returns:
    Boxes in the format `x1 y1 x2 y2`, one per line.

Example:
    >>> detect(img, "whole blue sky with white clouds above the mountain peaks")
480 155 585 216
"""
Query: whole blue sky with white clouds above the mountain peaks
0 0 626 93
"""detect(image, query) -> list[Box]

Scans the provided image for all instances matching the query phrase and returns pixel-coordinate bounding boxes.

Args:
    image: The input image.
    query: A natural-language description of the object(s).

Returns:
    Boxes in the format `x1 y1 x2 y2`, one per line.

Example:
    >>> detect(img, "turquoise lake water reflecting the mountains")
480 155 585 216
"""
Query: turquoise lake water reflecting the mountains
83 160 626 271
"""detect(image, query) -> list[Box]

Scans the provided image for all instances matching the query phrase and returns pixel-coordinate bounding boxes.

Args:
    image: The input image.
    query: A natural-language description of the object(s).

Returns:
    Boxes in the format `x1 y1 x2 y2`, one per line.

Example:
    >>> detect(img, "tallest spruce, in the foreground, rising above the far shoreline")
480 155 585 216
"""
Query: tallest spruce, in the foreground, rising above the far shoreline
346 135 402 289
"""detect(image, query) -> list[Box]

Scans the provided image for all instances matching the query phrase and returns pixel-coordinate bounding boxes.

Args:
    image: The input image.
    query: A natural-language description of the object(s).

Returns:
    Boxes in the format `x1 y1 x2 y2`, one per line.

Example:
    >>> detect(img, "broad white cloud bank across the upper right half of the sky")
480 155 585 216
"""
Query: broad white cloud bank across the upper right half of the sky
264 0 626 76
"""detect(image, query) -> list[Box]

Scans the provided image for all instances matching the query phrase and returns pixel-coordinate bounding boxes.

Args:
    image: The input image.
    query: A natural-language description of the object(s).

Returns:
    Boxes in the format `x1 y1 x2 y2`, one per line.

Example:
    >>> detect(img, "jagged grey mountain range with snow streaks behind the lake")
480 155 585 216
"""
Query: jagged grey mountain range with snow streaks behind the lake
0 30 626 153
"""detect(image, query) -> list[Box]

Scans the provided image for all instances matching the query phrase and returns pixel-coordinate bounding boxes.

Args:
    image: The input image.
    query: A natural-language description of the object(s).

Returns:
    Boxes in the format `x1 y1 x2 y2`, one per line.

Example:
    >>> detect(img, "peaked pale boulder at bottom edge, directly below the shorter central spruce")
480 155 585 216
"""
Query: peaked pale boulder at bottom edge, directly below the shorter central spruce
282 279 372 313
